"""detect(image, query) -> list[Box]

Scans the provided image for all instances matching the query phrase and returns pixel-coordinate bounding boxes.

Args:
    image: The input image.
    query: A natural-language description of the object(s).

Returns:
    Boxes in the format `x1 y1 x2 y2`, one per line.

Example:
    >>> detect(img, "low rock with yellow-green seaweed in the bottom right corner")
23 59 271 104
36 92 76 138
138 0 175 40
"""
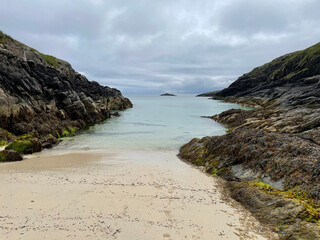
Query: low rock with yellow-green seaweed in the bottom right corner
226 181 320 240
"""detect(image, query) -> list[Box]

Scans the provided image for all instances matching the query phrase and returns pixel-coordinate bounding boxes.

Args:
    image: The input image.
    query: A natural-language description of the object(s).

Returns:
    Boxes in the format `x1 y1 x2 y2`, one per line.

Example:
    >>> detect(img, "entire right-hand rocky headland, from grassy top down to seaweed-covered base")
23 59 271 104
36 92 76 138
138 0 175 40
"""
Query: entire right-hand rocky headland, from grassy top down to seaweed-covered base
179 43 320 239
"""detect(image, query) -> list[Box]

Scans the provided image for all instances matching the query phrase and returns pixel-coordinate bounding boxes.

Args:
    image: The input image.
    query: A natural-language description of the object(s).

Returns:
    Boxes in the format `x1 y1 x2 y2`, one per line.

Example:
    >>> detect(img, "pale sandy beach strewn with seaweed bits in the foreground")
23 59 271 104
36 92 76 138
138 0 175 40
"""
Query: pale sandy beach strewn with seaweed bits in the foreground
0 151 277 240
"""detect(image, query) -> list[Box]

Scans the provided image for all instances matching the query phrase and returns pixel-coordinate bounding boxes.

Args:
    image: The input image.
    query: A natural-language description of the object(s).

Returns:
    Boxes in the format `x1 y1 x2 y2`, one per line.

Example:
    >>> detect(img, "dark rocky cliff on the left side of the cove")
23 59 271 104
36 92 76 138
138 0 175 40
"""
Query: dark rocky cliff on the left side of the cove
0 32 132 156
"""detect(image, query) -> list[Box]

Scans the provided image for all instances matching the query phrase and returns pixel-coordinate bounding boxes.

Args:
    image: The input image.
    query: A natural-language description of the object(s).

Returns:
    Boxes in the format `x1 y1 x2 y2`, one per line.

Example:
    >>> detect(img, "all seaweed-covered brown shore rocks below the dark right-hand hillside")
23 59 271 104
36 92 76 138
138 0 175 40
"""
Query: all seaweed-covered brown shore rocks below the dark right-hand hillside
178 97 320 240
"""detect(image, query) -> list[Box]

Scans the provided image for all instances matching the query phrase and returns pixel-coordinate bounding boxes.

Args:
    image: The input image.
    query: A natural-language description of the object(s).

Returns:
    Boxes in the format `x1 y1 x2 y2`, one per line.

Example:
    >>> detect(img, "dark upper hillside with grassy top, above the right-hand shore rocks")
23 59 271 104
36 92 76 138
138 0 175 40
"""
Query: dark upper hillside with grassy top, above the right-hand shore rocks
215 43 320 105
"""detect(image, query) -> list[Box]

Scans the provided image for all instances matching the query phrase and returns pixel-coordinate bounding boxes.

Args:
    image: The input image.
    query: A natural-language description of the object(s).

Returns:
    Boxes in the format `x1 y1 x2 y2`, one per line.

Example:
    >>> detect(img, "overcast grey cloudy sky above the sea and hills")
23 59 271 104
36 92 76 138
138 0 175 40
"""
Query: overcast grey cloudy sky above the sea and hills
0 0 320 94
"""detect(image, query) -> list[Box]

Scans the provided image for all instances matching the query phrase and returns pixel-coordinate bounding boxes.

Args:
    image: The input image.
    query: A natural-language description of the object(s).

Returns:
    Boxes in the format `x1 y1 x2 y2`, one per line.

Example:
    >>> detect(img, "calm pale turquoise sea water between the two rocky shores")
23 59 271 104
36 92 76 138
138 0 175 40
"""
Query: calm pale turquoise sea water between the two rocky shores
57 95 244 150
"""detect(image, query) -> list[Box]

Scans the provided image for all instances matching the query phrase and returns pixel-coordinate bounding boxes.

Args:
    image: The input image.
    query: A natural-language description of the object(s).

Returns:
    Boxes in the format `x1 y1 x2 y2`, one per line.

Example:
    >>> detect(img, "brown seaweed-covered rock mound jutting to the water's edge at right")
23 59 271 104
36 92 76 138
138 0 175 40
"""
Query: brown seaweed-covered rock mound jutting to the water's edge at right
179 129 320 202
